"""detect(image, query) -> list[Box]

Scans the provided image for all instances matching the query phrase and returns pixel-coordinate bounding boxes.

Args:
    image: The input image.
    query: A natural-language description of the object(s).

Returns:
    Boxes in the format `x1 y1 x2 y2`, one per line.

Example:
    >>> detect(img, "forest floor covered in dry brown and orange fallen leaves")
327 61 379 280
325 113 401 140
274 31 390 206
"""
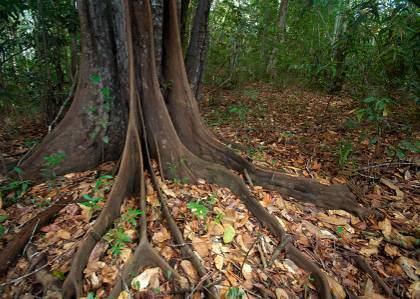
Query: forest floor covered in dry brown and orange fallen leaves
0 84 420 299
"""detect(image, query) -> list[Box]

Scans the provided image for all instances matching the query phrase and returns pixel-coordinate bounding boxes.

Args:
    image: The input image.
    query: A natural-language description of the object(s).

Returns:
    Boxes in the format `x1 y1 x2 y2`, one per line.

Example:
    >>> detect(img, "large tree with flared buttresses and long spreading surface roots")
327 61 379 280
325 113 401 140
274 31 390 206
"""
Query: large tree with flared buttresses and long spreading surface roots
6 0 366 298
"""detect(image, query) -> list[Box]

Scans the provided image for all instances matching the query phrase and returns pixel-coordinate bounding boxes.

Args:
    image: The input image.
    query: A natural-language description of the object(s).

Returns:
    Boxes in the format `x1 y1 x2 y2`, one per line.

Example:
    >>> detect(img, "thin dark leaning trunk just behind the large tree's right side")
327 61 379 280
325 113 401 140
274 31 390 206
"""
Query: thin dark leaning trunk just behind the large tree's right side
185 0 211 98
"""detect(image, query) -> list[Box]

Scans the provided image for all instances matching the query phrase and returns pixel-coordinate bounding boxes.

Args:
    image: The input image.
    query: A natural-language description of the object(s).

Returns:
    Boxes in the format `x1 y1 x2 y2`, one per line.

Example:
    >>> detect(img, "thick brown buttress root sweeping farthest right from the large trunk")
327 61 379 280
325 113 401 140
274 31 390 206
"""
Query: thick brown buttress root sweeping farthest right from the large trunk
159 0 368 217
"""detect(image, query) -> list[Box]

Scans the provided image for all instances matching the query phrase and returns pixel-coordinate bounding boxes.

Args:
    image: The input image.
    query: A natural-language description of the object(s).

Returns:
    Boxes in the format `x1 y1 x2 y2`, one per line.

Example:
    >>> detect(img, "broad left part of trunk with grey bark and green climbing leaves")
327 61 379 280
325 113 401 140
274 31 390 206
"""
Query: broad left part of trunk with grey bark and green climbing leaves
22 0 128 180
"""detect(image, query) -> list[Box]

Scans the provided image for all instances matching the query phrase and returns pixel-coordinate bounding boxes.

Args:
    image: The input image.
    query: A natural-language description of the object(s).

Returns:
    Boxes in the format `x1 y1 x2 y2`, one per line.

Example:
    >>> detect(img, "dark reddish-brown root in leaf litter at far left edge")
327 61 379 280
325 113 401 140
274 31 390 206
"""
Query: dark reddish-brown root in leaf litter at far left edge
0 197 72 274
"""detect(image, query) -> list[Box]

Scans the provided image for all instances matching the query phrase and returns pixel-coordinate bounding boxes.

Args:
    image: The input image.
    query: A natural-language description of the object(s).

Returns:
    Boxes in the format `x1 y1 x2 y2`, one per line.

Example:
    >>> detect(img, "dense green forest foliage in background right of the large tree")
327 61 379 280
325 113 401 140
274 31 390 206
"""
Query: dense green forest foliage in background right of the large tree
206 0 420 100
